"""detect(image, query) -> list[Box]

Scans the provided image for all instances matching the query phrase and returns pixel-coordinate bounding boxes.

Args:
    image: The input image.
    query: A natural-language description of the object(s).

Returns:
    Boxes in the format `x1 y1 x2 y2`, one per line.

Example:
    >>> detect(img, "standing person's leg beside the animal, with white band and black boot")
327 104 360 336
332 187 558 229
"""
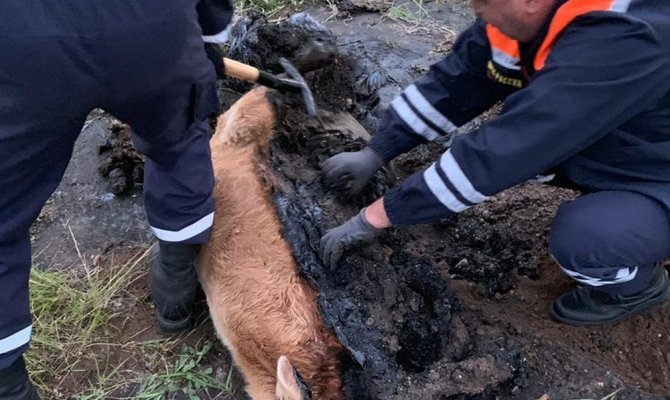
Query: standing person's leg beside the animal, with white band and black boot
103 9 218 333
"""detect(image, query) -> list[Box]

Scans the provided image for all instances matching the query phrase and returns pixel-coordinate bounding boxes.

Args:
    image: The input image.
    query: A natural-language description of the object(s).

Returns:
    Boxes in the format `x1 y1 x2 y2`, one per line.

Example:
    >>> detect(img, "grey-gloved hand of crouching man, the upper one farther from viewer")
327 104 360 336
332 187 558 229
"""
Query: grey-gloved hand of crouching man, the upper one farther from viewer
321 147 384 195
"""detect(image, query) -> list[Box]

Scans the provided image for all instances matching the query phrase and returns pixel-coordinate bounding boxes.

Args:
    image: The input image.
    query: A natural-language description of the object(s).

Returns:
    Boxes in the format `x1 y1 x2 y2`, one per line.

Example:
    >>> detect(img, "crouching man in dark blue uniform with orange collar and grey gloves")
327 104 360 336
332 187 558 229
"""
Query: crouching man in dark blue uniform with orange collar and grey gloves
321 0 670 326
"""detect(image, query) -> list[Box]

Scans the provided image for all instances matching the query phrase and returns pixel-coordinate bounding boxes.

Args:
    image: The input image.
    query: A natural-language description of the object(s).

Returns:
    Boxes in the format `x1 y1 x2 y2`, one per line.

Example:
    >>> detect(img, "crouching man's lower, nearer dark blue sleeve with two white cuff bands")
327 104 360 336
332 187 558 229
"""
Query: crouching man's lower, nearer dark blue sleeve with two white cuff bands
383 13 670 226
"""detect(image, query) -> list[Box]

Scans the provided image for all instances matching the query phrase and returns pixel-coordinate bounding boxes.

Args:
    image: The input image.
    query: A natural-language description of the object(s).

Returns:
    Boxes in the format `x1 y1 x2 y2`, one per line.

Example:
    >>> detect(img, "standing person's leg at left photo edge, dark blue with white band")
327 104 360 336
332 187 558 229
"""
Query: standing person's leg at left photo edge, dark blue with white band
0 26 98 400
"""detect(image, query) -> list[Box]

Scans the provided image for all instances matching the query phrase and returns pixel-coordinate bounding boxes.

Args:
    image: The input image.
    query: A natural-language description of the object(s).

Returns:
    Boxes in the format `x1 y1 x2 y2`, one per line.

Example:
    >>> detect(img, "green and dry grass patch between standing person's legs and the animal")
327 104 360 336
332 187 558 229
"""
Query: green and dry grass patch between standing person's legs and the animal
26 247 233 400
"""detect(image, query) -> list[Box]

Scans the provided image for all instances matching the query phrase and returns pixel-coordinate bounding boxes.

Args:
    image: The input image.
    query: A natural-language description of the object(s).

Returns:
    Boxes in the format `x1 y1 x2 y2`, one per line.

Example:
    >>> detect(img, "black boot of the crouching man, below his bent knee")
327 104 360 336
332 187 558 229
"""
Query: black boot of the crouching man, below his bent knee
551 264 670 326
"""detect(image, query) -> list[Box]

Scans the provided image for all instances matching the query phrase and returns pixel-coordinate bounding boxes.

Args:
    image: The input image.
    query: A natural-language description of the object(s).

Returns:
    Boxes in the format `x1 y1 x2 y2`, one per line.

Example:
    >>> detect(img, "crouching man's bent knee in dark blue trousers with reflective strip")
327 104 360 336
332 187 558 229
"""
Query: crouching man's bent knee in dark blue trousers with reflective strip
549 191 670 295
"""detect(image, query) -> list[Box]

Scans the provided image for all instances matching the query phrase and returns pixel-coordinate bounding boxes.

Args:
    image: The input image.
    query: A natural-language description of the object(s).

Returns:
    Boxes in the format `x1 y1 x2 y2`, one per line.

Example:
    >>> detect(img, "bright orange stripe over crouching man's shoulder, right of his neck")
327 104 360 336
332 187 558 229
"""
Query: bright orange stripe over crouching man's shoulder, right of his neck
533 0 631 71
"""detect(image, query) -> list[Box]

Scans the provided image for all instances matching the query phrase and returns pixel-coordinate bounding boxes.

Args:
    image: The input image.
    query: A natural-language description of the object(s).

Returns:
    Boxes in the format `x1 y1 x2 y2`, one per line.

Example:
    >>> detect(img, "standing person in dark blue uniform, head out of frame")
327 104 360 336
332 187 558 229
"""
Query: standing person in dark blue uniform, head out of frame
0 0 232 400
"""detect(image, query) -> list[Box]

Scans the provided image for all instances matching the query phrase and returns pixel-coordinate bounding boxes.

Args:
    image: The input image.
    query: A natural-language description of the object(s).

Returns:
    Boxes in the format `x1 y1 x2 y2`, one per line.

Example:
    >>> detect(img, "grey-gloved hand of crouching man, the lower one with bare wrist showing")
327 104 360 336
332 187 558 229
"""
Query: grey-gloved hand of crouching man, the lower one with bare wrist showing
321 208 384 269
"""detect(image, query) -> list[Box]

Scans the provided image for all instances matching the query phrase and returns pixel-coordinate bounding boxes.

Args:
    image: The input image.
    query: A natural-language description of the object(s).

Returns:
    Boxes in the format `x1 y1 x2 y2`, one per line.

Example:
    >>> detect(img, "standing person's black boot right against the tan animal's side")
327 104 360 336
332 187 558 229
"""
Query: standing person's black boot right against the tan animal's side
150 240 198 334
